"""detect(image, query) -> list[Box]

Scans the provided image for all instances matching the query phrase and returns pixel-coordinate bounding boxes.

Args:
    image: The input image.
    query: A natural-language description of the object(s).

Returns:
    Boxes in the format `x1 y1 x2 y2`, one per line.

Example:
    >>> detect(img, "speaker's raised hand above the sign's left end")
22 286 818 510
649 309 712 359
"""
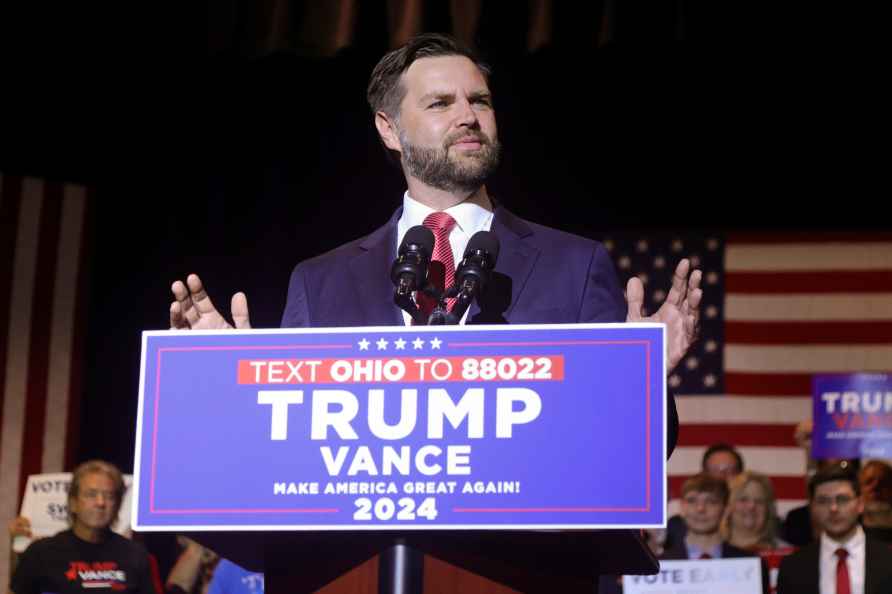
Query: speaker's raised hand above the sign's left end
170 274 251 330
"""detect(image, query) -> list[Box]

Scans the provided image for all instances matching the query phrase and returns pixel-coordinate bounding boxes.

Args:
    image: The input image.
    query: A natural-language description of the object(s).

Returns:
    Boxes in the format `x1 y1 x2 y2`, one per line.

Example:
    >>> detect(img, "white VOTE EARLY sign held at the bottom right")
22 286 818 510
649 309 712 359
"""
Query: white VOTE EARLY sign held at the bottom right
623 557 762 594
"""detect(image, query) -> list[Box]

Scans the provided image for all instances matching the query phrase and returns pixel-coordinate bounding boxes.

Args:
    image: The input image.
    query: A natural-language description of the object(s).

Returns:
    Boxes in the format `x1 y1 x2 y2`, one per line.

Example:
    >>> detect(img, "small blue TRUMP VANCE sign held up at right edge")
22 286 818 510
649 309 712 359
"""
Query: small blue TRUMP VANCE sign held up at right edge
812 373 892 459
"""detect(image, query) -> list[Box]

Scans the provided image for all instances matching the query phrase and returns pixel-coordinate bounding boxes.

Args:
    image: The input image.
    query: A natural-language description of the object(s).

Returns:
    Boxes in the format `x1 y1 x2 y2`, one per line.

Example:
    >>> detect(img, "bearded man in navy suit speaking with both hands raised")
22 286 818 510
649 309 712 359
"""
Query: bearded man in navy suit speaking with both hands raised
170 34 702 454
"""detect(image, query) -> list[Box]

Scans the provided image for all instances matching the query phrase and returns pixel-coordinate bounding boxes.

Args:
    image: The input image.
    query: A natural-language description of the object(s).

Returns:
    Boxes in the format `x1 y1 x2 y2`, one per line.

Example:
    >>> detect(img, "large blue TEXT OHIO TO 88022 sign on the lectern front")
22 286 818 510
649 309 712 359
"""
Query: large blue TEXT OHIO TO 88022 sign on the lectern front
133 324 666 530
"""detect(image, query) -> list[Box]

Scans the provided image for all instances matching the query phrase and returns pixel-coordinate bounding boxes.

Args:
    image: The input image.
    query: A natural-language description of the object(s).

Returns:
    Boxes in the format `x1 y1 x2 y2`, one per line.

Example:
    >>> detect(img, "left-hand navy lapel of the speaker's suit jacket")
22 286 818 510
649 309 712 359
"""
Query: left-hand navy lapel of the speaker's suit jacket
349 208 404 326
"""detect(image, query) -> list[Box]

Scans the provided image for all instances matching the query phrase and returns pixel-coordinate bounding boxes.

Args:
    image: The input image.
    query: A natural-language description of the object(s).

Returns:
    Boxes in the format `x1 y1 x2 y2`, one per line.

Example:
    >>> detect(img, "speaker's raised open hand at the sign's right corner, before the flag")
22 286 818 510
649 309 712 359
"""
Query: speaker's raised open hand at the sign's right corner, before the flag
626 258 703 371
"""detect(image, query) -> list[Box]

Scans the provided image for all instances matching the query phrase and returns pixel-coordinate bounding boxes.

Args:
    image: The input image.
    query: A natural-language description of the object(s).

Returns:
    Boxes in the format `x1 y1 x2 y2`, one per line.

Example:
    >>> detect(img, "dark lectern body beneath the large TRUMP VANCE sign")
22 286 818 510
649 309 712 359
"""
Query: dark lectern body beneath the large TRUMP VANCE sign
190 530 659 594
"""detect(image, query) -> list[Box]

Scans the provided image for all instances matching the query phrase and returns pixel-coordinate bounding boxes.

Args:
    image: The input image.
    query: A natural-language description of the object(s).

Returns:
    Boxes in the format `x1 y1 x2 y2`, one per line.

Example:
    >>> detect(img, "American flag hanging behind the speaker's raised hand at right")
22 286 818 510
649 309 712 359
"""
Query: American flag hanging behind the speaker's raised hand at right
604 233 892 516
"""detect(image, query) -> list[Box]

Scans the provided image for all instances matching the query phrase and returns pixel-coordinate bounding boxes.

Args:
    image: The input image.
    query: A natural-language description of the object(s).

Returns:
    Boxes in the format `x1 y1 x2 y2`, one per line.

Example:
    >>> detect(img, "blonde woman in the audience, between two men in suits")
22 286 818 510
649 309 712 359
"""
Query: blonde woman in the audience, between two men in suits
721 471 789 552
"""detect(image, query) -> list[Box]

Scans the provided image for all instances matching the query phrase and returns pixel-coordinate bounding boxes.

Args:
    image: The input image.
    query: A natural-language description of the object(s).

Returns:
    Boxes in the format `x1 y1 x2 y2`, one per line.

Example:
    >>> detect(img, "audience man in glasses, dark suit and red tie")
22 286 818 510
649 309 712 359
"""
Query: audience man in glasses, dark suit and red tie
777 467 892 594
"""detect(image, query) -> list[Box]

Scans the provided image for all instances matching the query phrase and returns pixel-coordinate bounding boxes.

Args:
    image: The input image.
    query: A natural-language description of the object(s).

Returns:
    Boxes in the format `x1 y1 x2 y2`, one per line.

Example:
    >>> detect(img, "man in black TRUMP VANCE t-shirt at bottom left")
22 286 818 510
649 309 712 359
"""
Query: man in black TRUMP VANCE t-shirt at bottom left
10 460 158 594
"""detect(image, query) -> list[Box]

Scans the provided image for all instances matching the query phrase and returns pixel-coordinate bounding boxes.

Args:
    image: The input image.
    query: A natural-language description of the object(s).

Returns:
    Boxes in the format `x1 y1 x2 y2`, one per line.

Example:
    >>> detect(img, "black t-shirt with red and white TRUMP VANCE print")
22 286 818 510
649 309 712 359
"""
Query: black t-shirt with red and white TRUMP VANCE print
10 530 156 594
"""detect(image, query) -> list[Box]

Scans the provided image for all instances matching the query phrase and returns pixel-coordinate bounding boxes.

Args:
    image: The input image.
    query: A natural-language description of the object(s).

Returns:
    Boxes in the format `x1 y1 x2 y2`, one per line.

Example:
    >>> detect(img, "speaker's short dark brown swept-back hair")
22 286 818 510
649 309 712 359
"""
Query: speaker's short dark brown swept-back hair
366 33 490 118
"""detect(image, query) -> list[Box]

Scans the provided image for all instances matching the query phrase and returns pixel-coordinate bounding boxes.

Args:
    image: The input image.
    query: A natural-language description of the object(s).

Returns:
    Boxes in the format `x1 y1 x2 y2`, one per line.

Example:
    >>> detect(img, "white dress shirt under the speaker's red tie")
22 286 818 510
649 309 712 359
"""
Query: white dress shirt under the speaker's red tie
396 191 493 326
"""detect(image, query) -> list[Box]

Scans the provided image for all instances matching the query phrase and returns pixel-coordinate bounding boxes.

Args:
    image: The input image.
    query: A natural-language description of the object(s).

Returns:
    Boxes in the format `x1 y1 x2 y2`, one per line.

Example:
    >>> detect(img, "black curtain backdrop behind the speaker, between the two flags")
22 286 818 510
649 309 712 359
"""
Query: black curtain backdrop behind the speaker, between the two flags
0 0 889 470
